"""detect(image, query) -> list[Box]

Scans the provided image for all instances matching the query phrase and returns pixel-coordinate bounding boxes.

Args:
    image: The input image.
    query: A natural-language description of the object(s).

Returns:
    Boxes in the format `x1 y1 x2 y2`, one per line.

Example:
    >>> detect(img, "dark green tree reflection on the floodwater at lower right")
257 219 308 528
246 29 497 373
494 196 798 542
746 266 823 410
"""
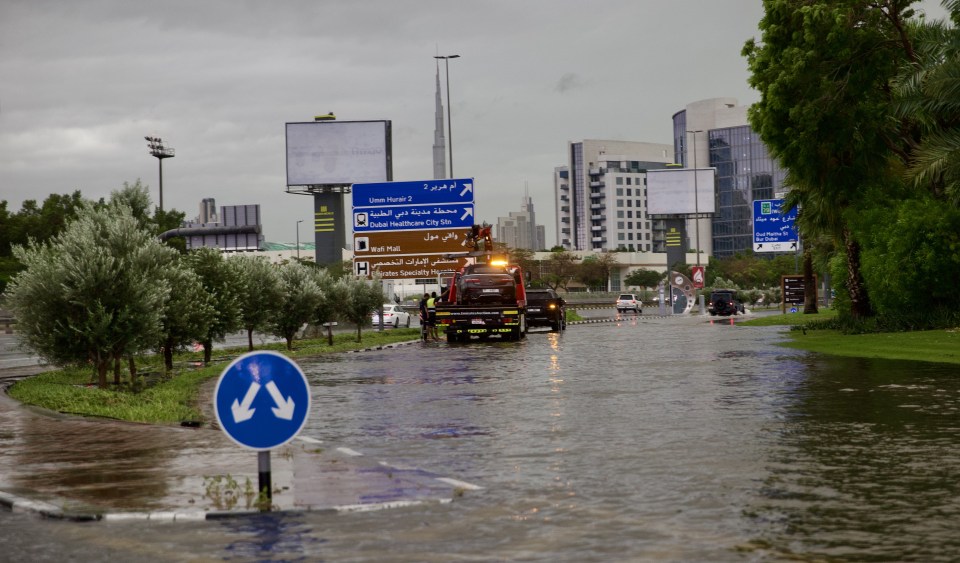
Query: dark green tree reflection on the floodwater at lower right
745 357 960 561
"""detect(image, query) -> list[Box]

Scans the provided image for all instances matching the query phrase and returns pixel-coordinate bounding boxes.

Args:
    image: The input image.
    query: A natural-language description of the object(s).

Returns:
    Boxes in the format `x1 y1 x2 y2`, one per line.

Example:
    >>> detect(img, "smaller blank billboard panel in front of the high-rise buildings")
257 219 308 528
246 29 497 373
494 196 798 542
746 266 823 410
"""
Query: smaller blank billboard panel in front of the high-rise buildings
647 168 717 215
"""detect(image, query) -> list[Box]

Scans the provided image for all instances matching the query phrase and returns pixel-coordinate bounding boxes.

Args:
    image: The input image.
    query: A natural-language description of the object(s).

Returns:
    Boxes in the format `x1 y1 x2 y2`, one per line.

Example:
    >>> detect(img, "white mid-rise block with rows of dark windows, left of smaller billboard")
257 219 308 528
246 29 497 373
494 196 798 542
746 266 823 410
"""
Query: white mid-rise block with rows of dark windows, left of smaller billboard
554 140 674 252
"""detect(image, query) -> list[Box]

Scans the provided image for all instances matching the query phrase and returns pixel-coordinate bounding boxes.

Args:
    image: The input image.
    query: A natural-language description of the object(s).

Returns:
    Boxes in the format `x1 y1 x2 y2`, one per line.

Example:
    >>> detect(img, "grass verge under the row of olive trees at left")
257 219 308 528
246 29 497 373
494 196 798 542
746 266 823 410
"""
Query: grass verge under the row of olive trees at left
8 328 420 424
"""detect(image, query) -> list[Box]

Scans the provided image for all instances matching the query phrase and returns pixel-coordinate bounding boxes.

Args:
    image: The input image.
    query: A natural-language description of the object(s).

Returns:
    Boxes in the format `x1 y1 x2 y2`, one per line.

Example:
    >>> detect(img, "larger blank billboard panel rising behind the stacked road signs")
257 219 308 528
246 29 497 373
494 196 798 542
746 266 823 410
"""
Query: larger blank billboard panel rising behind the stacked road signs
287 121 392 186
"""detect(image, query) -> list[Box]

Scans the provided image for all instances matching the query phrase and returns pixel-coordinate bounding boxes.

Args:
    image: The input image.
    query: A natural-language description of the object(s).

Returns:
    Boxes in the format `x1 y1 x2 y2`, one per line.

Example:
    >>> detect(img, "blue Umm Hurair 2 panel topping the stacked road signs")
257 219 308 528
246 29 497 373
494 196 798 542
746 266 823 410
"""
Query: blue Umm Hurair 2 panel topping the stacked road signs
352 178 473 207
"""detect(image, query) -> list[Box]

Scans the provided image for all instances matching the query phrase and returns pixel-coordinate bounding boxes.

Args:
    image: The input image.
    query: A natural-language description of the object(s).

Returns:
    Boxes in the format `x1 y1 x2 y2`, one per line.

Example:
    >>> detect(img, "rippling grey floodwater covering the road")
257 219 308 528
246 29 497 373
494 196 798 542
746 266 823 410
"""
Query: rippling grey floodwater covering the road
0 315 960 562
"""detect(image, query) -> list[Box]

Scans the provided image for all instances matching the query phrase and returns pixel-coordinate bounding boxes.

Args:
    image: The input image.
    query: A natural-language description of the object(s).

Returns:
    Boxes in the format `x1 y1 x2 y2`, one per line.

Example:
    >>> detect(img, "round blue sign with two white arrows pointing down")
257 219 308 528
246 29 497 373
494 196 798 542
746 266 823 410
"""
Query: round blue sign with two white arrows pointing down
213 351 310 451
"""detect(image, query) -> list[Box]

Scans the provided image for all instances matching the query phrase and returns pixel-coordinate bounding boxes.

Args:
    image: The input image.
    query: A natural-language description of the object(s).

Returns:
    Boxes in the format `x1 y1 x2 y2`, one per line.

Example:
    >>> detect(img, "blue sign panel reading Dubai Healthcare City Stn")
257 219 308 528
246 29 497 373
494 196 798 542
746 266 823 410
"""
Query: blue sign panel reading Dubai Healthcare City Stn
353 203 473 233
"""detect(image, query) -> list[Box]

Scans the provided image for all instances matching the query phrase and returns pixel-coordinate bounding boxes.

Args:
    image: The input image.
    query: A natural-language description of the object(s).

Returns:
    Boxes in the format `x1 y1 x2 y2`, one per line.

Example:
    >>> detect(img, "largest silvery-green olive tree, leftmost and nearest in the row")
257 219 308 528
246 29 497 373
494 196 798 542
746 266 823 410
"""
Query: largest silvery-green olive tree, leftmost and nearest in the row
7 204 171 387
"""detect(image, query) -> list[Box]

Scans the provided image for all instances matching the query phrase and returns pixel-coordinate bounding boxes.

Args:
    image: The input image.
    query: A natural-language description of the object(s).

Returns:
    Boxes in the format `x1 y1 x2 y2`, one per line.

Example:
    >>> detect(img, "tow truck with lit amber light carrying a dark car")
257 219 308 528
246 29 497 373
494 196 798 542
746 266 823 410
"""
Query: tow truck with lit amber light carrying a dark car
436 225 527 342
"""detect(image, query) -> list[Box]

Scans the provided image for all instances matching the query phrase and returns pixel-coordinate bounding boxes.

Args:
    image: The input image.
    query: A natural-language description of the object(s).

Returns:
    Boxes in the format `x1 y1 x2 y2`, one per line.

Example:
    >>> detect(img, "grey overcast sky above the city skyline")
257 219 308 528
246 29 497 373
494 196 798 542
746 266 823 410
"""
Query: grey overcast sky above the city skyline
0 0 944 246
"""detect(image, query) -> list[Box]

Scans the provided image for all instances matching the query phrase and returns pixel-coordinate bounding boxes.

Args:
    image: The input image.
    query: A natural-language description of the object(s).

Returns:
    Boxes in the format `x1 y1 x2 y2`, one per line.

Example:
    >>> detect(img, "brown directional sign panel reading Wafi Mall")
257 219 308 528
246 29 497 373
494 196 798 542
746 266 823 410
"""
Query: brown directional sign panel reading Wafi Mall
353 229 470 260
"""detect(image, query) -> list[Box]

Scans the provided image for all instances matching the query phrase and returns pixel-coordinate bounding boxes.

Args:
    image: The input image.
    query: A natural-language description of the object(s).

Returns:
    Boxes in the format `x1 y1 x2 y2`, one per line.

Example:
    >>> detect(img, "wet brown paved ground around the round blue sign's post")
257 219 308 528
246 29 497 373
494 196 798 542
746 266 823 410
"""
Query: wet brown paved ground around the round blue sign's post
0 333 479 520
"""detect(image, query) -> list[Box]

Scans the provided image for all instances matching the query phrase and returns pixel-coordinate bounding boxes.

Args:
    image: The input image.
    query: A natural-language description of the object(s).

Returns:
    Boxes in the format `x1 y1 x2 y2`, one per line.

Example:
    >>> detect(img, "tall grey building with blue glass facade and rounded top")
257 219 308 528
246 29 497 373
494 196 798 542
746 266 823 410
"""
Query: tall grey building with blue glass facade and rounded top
673 98 787 258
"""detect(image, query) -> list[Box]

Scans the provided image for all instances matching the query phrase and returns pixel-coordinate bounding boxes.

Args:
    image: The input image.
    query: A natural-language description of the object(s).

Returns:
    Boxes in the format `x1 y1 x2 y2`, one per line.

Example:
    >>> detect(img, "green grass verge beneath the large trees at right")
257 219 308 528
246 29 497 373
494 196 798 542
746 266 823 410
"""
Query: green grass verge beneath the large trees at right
739 309 960 364
